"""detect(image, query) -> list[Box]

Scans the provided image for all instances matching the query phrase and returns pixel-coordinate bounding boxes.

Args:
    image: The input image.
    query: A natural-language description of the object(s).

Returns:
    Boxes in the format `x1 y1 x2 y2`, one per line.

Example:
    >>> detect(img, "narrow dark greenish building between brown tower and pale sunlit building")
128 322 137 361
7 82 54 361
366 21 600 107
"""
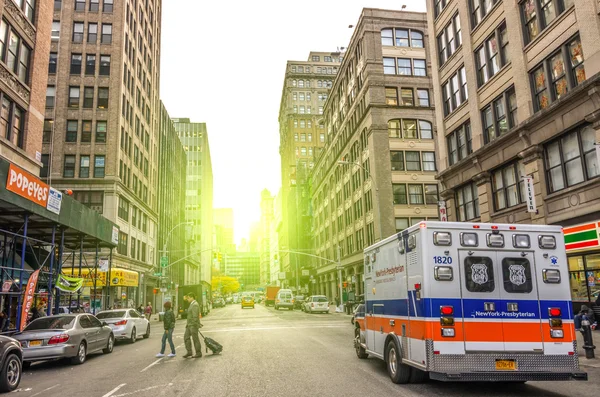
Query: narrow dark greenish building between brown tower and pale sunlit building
157 101 188 296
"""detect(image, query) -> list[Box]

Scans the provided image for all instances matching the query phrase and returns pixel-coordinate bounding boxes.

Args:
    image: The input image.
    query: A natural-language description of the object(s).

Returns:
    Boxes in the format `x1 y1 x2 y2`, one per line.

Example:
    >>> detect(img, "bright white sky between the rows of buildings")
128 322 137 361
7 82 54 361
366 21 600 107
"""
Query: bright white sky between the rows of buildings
160 0 425 243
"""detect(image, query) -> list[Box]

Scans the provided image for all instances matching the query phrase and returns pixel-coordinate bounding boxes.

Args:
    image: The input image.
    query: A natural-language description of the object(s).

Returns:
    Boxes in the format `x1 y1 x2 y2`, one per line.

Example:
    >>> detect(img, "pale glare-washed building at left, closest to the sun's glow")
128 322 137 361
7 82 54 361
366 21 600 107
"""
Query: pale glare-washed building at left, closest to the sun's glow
173 118 214 290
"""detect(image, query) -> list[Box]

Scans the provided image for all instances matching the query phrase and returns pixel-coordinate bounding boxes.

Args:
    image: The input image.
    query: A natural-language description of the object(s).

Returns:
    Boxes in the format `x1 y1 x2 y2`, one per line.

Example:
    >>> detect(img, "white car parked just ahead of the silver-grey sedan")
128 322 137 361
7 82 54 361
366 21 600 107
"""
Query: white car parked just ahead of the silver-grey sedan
96 309 150 343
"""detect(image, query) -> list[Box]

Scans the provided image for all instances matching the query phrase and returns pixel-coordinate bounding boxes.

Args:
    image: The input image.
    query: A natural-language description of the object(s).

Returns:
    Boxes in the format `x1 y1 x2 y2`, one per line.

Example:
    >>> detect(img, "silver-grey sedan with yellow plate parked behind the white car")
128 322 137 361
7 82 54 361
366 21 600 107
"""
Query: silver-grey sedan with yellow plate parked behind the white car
14 313 115 368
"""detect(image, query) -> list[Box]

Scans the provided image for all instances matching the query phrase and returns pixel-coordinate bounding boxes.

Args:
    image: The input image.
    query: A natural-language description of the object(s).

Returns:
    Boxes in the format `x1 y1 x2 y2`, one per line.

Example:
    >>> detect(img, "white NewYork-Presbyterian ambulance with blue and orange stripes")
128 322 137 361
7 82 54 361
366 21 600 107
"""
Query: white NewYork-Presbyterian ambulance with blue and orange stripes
354 222 587 383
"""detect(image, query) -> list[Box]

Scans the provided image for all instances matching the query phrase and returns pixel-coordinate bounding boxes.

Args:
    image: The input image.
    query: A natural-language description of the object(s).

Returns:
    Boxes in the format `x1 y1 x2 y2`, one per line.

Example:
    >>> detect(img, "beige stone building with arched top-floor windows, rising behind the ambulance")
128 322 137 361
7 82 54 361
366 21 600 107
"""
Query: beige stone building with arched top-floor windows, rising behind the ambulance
311 8 438 298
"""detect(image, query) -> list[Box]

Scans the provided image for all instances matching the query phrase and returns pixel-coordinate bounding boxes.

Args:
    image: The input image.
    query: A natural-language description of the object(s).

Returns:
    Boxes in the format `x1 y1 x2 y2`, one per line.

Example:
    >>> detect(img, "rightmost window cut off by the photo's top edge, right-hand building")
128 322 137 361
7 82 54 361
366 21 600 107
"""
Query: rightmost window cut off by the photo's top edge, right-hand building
521 0 574 44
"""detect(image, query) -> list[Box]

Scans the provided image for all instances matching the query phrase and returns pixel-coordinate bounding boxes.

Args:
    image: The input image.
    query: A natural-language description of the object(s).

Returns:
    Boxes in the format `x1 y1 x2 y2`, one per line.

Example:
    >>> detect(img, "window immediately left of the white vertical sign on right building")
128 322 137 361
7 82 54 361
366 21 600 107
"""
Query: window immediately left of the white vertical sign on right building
492 162 525 211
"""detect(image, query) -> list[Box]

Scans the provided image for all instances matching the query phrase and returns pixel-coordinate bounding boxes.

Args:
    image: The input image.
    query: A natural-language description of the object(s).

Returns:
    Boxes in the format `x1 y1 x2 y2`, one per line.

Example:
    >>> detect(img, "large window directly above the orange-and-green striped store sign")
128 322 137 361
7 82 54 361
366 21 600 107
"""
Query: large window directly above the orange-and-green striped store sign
544 125 600 193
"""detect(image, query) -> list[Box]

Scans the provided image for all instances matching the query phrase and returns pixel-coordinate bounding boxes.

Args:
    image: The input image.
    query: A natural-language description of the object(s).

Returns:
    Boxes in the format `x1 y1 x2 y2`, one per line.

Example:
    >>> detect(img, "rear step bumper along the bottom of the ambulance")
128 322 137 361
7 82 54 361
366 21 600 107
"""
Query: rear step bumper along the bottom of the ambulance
429 371 587 382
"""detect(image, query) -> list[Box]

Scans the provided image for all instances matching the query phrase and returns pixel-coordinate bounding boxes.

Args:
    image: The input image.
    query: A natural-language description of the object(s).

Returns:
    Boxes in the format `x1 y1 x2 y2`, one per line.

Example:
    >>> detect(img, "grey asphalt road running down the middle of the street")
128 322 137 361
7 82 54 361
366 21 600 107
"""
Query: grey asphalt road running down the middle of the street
8 305 600 397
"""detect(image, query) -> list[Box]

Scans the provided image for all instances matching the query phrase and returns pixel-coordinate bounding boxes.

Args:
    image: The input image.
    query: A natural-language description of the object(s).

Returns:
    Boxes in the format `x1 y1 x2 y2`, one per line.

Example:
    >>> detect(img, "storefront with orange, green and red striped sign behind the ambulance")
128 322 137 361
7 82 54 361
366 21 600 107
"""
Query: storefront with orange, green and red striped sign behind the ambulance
564 220 600 311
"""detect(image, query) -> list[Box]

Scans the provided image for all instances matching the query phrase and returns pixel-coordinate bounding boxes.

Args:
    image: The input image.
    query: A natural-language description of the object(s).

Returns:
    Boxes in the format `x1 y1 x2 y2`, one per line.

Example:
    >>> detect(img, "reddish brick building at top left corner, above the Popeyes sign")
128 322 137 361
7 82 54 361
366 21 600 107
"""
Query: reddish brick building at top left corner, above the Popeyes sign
0 1 52 175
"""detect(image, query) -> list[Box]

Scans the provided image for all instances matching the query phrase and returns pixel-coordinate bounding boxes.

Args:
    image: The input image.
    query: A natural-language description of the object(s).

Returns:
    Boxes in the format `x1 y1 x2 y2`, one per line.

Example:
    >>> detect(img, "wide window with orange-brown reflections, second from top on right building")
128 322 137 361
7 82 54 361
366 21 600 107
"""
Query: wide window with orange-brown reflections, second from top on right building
530 36 586 111
